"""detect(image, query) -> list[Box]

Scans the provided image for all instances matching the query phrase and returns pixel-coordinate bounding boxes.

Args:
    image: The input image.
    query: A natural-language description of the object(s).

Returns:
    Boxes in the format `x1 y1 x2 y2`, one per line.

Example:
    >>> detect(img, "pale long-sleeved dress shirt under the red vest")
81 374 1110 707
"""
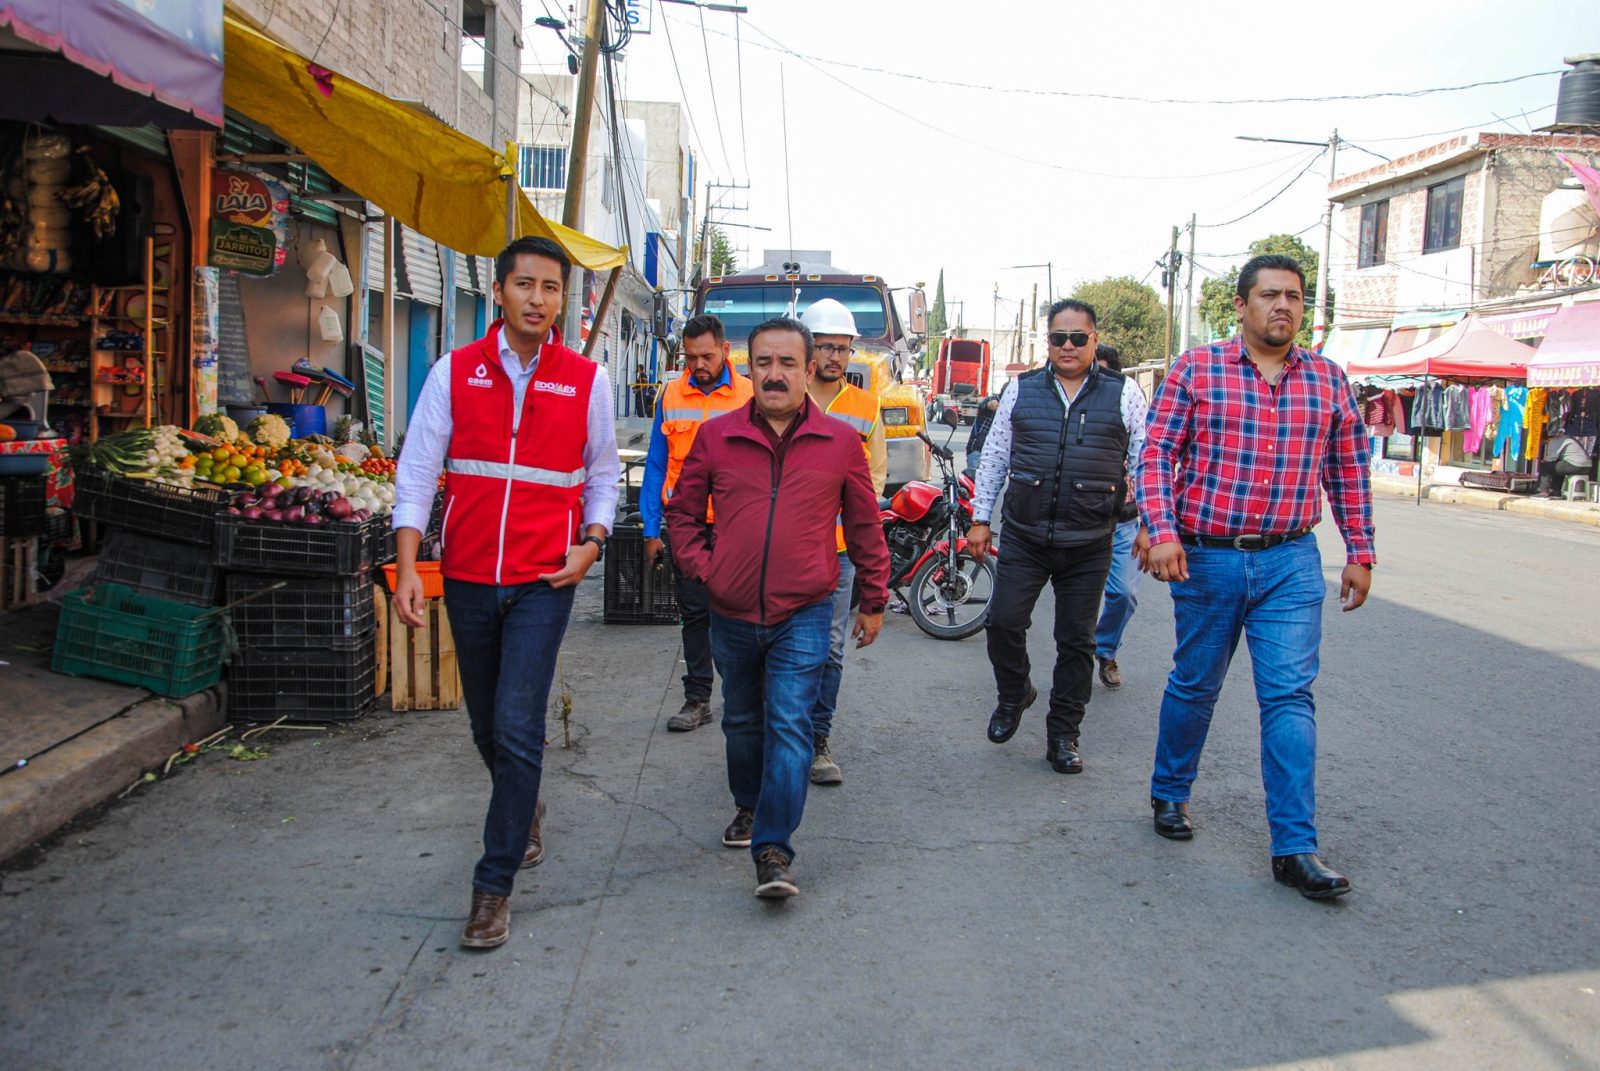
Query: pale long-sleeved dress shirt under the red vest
394 328 622 533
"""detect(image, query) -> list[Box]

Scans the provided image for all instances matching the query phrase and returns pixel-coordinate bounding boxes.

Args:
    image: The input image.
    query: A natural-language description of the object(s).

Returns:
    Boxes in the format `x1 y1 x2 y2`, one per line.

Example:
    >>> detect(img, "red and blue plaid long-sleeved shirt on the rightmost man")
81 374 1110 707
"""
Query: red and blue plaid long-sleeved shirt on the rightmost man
1139 338 1376 562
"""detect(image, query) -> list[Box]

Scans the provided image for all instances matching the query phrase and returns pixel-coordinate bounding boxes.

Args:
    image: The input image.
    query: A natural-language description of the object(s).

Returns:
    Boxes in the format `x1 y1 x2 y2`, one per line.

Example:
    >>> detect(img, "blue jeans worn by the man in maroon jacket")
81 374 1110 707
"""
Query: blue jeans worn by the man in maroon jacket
710 599 834 860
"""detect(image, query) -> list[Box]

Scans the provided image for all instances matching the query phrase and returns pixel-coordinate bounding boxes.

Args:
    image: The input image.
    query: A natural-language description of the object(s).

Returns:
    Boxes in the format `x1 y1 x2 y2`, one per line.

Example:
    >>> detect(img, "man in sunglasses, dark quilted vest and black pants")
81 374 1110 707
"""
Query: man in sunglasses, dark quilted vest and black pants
966 298 1146 773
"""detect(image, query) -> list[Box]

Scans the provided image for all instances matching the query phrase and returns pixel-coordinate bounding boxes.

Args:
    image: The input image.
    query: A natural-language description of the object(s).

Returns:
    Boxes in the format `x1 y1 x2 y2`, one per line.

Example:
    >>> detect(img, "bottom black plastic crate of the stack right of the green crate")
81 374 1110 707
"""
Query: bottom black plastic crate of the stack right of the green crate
227 644 378 722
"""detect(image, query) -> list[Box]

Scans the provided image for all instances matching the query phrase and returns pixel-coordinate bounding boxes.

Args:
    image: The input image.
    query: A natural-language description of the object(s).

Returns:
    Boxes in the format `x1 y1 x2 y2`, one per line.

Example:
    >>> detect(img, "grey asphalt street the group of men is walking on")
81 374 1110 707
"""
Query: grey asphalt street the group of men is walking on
0 499 1600 1071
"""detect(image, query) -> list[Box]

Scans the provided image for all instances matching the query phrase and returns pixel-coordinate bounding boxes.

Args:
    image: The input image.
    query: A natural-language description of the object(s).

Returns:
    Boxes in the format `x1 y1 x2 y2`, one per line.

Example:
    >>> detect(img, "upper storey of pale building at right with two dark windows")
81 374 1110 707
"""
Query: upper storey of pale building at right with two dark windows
1330 133 1600 323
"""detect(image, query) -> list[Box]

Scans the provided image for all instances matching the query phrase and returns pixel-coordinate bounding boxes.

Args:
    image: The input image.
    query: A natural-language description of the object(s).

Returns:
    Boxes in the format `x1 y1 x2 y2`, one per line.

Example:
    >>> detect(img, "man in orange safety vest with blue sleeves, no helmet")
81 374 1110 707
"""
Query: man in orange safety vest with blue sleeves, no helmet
638 314 750 733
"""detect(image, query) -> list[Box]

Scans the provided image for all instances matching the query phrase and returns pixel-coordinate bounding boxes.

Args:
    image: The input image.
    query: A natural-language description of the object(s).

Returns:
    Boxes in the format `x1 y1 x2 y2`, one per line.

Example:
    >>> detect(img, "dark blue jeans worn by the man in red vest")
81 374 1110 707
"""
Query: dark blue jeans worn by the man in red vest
445 580 578 897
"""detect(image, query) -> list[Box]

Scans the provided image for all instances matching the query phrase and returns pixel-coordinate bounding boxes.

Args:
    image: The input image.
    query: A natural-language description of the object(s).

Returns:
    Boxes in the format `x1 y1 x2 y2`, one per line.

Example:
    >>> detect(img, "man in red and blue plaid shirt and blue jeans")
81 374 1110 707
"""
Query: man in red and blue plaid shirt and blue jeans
1138 256 1374 900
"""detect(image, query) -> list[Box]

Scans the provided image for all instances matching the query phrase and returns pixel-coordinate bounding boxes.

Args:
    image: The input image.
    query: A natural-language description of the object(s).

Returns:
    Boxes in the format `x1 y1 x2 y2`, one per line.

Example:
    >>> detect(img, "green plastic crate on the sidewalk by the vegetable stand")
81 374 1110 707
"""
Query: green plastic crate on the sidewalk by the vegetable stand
50 584 227 700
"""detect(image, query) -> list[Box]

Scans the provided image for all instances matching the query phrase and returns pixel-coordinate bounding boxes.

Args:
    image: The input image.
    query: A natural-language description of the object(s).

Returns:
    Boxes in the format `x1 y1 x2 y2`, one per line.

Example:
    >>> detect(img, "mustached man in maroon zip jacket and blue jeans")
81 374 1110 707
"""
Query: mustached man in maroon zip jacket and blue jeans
667 317 890 898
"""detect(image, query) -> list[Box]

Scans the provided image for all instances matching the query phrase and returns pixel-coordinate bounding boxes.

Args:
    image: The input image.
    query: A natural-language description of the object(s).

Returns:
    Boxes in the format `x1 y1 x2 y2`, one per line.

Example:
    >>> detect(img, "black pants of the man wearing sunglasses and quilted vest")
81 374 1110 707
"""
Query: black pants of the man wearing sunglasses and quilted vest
989 531 1112 740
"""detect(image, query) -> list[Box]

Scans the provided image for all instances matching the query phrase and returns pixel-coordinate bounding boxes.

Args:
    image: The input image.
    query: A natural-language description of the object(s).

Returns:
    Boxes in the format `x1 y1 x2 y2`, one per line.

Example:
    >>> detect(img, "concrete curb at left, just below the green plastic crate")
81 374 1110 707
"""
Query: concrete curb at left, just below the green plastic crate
0 688 227 861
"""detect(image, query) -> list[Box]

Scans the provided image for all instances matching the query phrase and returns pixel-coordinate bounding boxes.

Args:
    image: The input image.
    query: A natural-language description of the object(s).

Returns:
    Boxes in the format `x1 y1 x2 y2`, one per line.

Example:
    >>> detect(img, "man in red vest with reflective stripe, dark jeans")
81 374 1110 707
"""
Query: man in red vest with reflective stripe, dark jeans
394 239 619 948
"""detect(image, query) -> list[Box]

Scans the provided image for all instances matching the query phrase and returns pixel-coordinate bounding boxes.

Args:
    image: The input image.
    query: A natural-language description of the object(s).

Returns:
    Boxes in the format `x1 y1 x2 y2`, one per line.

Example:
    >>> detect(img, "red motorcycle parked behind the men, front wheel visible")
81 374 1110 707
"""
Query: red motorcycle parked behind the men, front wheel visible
883 410 995 640
